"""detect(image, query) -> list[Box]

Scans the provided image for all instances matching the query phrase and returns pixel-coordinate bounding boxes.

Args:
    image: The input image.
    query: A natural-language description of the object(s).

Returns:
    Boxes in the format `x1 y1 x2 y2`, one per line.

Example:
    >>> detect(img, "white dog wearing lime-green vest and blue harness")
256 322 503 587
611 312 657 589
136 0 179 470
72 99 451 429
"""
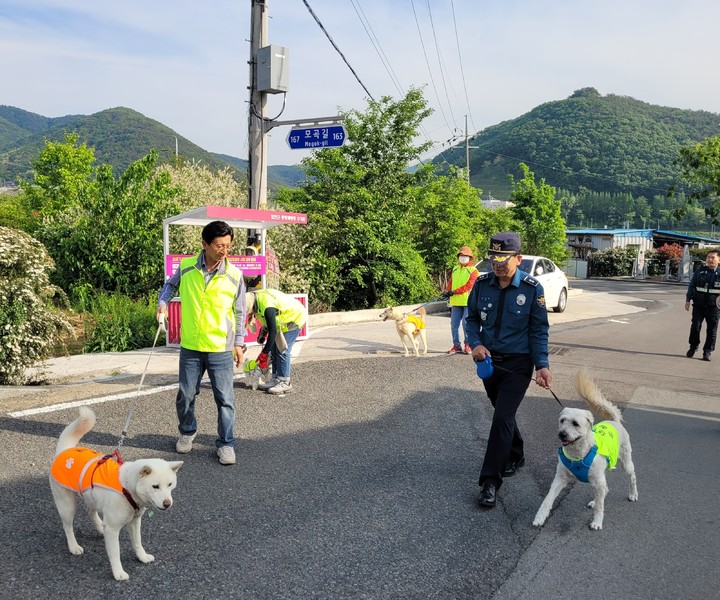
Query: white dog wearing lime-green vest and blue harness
533 371 638 530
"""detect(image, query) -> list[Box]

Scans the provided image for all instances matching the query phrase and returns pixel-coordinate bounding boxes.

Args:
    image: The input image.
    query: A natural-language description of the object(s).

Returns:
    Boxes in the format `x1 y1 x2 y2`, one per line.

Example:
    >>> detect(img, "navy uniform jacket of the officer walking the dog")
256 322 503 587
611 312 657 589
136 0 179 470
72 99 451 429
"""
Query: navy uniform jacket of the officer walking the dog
466 269 550 369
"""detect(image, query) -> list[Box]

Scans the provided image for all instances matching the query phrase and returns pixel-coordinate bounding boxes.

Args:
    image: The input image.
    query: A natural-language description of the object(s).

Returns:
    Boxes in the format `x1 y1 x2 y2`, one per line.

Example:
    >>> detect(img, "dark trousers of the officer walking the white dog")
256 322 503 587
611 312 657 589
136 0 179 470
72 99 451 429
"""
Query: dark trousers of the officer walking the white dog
480 354 533 488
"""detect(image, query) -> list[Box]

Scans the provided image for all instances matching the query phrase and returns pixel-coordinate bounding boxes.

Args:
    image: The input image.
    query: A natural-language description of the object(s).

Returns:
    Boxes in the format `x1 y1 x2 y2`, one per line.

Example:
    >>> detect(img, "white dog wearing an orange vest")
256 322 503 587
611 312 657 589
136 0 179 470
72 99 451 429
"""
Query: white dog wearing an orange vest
50 406 182 581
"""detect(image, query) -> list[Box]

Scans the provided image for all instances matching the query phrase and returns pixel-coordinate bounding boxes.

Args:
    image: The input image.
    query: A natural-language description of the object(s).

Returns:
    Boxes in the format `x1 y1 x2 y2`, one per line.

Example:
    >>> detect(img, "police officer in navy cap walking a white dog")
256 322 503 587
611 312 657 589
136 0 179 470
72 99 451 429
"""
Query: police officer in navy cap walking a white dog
467 233 552 507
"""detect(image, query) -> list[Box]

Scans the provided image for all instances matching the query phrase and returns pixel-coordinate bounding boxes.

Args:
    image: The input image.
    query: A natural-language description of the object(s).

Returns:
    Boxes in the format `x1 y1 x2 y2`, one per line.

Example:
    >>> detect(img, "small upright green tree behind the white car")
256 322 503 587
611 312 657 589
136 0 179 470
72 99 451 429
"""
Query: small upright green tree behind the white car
509 163 567 263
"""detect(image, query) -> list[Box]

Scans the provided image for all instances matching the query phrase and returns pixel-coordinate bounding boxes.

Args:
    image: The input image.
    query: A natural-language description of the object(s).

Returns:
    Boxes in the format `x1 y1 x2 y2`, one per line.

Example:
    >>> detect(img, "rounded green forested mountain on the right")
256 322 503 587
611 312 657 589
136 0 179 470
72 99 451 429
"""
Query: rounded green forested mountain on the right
433 88 720 199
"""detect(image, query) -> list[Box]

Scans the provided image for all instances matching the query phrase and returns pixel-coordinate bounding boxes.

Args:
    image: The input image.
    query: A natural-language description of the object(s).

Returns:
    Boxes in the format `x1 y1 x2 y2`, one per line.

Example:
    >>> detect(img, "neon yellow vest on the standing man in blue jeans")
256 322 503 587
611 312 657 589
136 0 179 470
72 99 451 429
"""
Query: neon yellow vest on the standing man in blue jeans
178 255 242 352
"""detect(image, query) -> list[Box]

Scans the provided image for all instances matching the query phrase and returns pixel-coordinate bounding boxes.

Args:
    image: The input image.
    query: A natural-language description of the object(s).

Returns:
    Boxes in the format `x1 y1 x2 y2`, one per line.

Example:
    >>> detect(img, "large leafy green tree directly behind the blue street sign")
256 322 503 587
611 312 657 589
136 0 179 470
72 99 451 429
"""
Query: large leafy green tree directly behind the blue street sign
277 89 434 310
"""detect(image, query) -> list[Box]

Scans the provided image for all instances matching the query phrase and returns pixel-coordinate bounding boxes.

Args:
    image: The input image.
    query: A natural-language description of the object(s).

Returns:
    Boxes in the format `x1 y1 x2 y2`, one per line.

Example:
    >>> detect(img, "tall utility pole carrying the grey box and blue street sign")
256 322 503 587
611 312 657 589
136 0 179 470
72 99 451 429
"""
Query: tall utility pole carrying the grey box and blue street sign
248 0 268 216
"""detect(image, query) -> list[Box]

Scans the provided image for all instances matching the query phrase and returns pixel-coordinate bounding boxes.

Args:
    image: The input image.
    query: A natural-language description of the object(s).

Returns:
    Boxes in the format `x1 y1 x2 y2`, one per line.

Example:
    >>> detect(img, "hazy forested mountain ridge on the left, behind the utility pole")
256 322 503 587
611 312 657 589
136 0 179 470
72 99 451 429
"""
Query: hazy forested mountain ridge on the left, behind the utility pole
0 106 304 186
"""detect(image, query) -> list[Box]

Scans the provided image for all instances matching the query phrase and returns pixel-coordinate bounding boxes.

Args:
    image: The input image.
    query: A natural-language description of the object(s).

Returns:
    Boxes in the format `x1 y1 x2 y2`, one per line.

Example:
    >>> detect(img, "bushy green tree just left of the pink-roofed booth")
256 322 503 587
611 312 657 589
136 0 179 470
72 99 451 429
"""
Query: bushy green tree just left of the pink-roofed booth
37 151 178 298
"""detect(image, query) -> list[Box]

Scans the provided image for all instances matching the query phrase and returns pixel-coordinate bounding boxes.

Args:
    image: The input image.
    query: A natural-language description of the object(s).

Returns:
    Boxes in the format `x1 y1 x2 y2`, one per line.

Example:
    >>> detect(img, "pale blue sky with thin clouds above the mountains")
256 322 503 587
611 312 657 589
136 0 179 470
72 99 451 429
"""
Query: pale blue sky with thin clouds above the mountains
0 0 720 165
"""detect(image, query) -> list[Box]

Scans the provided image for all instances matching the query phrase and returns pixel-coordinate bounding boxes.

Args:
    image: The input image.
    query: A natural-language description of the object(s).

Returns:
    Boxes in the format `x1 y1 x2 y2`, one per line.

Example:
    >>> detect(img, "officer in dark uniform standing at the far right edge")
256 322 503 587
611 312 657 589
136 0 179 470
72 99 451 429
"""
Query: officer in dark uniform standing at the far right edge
685 250 720 362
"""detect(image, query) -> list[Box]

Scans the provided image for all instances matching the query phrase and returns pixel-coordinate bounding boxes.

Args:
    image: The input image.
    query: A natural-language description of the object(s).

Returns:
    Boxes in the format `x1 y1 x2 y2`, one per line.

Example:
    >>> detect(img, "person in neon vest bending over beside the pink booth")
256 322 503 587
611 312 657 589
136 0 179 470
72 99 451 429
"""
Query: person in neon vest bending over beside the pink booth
245 288 307 394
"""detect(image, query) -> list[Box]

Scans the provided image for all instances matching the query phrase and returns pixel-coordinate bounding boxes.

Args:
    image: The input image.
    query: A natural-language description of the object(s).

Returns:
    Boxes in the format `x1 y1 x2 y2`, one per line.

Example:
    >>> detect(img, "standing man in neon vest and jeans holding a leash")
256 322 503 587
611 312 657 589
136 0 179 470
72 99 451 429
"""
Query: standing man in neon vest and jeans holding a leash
157 221 246 465
